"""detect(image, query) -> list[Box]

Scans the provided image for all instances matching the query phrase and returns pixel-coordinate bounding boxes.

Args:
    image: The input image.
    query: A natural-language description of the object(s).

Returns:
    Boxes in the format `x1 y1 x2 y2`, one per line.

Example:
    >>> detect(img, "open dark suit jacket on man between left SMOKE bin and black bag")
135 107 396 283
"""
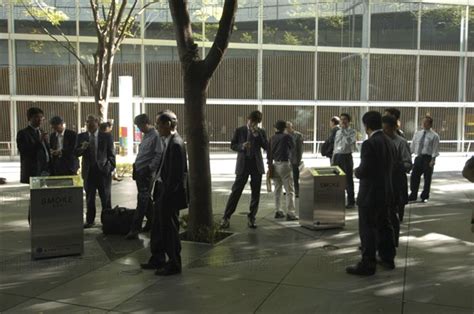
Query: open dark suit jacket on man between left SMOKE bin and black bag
75 132 115 181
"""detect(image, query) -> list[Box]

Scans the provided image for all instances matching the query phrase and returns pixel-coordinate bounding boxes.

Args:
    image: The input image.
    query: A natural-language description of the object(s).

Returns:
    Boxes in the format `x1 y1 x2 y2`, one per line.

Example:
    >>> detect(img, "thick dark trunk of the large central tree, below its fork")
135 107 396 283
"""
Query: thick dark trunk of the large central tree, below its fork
184 71 213 239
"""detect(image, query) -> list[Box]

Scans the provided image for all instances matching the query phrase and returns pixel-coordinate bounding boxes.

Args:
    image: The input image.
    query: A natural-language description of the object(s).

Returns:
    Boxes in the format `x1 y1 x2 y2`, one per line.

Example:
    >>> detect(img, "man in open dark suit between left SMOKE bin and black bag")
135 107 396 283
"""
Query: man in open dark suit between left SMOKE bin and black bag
75 115 115 228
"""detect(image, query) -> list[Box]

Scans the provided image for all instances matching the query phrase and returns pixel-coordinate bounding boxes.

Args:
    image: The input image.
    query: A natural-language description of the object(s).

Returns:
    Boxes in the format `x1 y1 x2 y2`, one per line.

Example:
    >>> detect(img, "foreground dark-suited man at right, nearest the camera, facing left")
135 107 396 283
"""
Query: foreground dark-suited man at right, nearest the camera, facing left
346 111 396 276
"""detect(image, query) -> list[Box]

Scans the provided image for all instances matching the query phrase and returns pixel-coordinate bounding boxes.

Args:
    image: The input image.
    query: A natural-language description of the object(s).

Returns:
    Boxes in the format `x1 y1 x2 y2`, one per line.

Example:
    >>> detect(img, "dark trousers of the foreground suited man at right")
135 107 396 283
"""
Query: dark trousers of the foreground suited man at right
359 207 396 263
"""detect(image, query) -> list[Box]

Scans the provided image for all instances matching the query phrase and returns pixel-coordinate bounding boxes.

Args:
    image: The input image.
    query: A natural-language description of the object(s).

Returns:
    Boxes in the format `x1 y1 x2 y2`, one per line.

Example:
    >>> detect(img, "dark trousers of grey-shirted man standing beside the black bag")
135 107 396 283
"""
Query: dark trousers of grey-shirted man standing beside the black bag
131 169 153 232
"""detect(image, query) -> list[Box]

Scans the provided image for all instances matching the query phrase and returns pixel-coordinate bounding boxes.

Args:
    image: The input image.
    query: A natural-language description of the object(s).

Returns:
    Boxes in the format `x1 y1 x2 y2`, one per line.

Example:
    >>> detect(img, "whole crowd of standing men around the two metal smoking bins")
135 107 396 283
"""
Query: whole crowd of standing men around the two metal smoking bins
17 107 439 275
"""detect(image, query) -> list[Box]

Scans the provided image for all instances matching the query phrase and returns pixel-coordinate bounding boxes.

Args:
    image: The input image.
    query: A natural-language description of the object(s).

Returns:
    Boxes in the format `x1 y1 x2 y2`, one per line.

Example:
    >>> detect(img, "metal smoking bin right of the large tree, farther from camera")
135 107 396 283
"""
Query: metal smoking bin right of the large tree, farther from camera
299 166 346 230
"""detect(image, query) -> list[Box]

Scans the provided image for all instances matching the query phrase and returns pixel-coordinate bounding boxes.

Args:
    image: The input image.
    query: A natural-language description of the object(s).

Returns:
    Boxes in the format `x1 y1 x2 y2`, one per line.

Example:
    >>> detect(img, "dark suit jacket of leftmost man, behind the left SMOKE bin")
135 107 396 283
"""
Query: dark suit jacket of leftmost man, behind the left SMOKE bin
16 126 50 184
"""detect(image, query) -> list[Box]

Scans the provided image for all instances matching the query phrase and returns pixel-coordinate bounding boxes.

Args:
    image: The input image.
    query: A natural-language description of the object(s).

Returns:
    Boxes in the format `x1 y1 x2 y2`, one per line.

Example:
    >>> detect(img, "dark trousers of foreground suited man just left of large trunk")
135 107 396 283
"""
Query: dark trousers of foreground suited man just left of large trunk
148 183 181 269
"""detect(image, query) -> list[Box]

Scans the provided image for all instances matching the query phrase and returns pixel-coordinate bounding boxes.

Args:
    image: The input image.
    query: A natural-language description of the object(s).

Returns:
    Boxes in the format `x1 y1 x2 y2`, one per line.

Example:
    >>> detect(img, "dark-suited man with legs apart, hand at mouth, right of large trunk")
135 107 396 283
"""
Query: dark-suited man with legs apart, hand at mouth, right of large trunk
221 111 268 229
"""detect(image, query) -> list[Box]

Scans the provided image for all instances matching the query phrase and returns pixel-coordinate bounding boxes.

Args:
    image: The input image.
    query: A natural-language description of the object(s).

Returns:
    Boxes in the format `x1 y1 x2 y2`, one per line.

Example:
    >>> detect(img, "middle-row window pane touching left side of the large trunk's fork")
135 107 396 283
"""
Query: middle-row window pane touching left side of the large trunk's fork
145 46 184 98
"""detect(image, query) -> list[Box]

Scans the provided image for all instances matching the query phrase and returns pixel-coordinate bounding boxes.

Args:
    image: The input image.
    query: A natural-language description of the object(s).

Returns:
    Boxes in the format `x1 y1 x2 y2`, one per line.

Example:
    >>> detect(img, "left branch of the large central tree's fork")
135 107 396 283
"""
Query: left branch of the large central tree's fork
169 0 200 66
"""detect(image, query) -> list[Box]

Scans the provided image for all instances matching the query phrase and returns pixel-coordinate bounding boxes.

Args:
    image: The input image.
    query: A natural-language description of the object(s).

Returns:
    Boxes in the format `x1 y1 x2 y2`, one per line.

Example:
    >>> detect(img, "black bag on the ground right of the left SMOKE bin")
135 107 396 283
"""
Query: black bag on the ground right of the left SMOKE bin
101 206 135 235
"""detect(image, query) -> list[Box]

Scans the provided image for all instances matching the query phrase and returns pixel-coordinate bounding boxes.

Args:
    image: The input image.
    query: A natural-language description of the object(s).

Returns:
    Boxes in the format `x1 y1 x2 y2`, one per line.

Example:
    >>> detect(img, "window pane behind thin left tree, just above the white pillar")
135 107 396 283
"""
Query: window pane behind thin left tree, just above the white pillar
81 43 141 96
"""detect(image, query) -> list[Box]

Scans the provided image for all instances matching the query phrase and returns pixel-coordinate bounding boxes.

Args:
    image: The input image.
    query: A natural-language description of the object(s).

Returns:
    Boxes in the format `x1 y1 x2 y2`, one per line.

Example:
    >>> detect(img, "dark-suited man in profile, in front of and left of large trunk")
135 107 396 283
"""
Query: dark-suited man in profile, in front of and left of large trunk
140 110 188 276
